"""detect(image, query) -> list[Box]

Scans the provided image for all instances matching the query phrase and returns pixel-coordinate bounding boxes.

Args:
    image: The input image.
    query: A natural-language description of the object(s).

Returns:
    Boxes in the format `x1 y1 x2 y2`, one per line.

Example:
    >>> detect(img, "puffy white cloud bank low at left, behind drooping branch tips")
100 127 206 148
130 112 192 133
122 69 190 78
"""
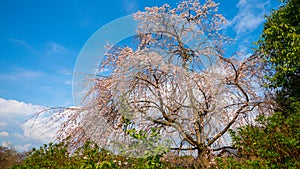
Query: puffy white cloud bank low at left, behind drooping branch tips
0 98 77 150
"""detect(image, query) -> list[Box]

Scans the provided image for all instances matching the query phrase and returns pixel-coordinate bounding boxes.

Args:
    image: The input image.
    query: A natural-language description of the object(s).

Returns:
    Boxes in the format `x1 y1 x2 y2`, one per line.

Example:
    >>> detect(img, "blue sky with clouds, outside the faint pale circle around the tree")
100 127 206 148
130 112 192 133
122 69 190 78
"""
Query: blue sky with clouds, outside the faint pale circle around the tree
0 0 279 151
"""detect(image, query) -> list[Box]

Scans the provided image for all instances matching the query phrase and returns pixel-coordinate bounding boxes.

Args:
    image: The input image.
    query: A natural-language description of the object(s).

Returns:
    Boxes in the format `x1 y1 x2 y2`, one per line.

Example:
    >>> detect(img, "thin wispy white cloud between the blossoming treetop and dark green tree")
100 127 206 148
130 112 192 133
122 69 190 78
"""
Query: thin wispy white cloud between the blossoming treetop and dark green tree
227 0 270 36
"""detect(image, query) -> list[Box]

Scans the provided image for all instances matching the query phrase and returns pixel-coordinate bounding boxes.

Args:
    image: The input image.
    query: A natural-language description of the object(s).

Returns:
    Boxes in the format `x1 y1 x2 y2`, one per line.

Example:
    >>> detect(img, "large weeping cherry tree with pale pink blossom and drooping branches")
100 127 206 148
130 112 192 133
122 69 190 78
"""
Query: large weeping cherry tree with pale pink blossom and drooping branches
58 0 267 164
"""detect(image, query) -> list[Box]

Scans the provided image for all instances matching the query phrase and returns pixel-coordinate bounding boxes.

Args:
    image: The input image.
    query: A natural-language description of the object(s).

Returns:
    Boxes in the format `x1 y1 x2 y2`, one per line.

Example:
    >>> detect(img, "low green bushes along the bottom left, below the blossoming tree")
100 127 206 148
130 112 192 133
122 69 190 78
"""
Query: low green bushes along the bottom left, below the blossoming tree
13 141 176 169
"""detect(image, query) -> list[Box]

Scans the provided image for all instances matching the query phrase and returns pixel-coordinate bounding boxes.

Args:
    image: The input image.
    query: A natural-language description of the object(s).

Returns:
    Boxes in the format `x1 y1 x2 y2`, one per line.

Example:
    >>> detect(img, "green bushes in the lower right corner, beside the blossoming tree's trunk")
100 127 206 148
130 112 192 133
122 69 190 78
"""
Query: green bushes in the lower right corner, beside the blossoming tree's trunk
219 104 300 168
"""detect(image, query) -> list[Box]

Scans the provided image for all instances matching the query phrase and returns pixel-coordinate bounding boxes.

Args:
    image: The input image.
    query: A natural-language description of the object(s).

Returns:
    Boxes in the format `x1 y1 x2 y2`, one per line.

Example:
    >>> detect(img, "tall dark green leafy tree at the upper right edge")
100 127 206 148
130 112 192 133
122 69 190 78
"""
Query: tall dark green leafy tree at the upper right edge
259 0 300 108
